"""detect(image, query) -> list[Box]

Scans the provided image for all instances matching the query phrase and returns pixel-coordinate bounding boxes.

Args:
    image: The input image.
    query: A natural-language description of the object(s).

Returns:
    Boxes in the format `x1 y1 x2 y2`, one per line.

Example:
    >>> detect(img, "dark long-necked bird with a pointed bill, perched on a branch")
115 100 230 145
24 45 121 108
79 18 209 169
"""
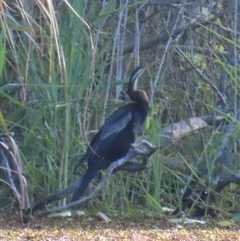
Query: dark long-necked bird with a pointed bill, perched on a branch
71 65 150 202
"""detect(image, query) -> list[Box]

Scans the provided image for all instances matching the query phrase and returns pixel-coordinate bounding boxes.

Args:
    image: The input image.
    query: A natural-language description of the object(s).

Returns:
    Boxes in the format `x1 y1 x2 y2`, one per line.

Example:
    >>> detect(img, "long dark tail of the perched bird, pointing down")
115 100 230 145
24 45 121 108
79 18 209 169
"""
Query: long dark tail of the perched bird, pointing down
71 168 99 202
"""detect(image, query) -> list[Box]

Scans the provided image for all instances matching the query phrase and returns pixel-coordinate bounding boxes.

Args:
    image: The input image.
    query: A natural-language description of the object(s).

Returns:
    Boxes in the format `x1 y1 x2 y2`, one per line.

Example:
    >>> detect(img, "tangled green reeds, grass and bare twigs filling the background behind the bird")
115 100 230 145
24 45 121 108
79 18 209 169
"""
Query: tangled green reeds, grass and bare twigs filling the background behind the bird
0 0 240 218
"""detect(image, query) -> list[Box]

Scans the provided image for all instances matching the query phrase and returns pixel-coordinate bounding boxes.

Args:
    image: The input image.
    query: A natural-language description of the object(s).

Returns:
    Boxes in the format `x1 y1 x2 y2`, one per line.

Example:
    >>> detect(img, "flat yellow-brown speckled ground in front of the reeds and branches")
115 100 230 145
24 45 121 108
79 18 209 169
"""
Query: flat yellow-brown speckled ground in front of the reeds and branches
0 211 240 241
